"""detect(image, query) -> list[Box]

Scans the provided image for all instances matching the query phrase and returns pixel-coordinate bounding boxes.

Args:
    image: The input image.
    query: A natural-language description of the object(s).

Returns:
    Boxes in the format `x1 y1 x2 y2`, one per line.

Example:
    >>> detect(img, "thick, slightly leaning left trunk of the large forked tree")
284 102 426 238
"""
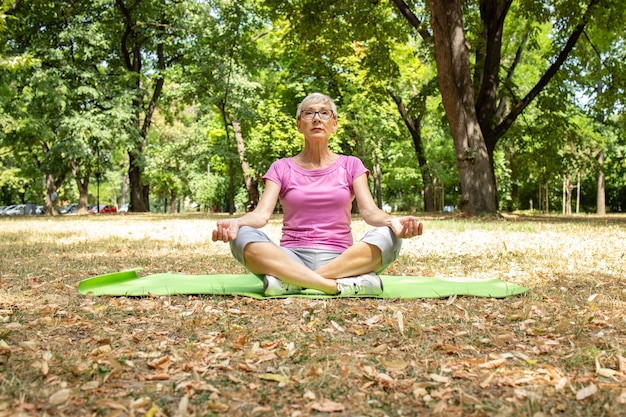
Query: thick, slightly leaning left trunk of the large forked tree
429 0 497 216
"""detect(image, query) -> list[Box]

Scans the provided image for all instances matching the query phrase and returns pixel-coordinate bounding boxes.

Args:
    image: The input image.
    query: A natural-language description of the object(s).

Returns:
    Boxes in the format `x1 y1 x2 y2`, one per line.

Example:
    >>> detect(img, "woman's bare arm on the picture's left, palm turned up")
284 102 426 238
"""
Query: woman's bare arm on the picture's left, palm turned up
213 180 280 243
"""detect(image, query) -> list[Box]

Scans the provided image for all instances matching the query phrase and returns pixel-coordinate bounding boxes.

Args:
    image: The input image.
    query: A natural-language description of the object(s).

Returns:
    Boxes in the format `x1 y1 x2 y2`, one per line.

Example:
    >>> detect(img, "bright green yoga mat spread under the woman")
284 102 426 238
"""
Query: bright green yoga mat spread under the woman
78 269 528 299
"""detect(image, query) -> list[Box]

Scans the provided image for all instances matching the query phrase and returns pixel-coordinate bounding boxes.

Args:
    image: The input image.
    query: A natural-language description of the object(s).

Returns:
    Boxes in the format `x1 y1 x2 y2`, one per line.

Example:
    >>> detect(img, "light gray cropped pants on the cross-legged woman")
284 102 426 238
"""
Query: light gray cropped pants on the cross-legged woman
230 226 402 274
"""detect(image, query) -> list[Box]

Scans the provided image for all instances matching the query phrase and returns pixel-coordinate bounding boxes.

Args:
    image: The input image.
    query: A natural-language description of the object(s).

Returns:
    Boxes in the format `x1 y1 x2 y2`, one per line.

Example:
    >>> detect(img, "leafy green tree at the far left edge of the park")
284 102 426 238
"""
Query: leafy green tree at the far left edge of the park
3 1 135 214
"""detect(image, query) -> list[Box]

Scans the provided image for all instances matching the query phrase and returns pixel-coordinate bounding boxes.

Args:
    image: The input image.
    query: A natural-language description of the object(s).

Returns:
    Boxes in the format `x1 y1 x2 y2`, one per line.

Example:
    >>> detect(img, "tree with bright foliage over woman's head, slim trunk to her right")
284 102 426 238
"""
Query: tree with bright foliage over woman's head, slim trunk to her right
268 1 442 211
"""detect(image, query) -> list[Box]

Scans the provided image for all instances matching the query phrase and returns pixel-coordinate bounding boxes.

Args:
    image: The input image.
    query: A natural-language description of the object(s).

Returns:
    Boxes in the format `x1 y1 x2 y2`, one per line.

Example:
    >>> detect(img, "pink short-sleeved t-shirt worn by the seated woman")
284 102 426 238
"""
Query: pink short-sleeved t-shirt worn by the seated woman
263 155 369 252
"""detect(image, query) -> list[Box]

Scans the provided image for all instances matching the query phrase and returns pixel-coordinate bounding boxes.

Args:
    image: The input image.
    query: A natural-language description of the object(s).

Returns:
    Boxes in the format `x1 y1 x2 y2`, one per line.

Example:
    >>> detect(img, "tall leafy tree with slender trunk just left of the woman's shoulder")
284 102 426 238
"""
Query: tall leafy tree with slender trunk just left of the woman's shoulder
181 1 267 213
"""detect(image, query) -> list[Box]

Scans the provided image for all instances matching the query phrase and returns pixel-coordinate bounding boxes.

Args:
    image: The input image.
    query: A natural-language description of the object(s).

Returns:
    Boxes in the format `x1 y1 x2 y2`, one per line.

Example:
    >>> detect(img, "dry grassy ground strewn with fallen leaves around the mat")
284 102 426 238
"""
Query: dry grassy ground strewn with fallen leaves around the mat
0 214 626 417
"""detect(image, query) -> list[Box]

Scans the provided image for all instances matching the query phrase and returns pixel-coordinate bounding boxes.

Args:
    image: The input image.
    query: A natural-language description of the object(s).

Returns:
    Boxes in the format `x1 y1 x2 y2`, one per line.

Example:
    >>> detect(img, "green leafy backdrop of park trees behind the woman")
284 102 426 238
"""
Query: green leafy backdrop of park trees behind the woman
0 0 626 214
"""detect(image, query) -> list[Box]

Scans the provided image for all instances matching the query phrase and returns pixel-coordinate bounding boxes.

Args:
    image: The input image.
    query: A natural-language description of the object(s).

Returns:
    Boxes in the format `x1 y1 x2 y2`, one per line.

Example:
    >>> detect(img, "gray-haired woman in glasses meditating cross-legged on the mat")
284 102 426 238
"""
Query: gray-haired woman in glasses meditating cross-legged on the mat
213 93 422 296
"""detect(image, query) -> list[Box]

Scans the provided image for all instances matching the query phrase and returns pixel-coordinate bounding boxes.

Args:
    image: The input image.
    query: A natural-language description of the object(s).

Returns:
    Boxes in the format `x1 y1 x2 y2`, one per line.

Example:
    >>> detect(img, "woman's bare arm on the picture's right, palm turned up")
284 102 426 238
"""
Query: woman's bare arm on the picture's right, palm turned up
352 174 423 238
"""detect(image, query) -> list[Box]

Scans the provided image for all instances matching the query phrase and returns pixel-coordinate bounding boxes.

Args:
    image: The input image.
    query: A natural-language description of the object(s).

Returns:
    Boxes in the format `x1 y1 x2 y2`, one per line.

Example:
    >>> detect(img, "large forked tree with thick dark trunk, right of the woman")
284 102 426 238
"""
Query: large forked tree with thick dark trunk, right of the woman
394 0 622 215
